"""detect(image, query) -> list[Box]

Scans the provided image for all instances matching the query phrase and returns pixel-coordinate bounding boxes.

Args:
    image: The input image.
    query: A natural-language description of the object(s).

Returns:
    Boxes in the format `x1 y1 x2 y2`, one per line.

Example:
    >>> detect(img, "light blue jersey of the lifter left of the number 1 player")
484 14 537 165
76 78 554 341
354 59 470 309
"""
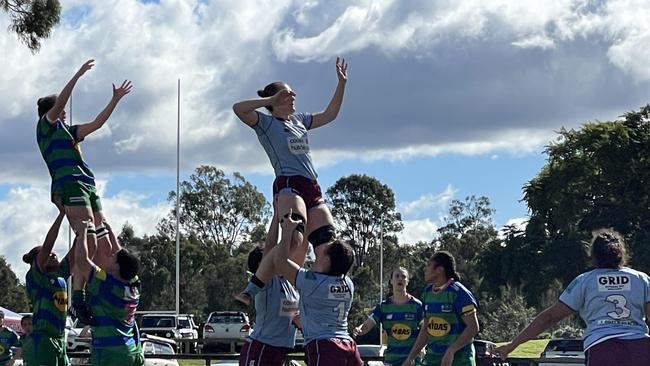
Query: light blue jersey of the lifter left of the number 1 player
250 276 299 348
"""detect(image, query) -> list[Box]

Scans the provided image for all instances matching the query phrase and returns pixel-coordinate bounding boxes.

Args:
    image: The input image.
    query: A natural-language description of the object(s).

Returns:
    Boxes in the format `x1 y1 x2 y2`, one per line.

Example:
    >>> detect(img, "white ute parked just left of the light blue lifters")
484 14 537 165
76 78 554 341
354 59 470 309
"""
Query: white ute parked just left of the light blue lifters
203 311 252 348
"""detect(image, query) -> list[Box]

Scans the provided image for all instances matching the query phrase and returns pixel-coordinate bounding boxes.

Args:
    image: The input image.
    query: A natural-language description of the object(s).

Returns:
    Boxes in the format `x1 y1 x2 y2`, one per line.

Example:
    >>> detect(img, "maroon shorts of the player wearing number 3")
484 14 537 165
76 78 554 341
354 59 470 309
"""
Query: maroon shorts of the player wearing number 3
585 338 650 366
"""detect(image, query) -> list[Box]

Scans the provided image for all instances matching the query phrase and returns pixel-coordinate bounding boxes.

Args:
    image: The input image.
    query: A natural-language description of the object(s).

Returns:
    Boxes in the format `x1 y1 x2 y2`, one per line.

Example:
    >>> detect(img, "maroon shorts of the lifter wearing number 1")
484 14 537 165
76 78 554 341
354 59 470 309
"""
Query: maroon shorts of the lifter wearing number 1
305 338 363 366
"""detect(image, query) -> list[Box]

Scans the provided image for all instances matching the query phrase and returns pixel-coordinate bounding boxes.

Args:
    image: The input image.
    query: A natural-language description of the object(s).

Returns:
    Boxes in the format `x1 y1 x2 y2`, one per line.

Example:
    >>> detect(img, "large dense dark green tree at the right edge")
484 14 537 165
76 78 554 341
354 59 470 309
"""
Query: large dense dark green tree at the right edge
524 105 650 285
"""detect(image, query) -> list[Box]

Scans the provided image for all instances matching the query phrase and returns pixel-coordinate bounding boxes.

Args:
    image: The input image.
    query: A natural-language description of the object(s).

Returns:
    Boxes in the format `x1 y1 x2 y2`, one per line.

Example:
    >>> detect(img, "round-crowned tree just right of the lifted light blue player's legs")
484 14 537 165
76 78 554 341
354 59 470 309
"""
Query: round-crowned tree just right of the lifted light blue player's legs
327 174 404 266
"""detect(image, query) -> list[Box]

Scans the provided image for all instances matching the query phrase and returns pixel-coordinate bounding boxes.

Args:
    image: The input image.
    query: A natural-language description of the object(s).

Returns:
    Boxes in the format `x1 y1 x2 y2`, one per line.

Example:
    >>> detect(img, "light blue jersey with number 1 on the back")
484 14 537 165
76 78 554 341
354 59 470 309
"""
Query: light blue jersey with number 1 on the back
296 268 354 344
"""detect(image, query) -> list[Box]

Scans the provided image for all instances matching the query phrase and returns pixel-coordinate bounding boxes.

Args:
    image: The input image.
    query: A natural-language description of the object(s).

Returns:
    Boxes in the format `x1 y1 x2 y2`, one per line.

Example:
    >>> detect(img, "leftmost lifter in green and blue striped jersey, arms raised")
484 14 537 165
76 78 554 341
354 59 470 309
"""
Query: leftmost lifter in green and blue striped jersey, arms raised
23 207 74 366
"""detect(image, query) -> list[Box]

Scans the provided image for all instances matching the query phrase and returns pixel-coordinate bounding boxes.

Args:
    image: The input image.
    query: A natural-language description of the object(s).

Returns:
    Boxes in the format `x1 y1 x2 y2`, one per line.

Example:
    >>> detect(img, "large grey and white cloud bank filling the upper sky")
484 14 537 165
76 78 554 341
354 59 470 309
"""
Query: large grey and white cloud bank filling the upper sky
0 0 650 183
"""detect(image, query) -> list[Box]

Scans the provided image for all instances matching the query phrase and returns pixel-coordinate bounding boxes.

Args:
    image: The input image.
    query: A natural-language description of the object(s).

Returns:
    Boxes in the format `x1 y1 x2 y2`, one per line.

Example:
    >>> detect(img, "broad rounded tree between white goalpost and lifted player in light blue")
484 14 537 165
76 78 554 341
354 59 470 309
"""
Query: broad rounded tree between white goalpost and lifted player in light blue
169 165 269 256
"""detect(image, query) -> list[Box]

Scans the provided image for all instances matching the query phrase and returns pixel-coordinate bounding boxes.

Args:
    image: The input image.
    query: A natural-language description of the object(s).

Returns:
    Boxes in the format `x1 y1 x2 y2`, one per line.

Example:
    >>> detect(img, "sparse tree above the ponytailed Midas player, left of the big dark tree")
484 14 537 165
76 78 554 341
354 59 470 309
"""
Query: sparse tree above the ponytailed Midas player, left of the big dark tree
434 195 498 292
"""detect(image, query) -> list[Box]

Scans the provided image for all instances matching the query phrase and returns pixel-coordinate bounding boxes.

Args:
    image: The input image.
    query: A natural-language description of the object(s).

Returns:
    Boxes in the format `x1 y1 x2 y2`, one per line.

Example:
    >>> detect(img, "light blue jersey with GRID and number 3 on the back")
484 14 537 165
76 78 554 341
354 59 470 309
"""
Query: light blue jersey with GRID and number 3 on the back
560 268 650 350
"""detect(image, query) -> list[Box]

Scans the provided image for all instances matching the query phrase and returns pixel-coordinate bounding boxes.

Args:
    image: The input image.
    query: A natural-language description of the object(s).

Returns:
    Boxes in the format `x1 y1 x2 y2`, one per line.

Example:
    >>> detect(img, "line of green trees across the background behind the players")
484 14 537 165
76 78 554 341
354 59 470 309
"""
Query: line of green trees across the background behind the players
5 106 650 341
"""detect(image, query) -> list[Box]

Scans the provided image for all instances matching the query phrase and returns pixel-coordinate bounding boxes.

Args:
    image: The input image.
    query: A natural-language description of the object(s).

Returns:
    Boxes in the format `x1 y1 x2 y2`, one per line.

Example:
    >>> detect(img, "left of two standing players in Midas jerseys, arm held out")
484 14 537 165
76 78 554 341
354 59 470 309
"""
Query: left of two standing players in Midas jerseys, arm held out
352 267 422 366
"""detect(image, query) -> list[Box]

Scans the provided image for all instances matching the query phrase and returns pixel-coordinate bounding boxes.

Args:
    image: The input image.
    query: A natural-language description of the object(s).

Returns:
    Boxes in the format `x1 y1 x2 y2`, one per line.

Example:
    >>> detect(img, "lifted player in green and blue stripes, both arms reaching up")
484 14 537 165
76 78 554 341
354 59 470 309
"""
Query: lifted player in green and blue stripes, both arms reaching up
36 60 131 266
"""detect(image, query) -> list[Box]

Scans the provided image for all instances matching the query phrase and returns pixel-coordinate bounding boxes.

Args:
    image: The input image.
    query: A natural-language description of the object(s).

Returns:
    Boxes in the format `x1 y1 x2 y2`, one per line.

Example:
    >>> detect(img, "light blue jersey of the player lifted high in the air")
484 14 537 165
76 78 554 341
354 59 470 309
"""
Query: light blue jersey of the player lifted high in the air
253 112 317 180
